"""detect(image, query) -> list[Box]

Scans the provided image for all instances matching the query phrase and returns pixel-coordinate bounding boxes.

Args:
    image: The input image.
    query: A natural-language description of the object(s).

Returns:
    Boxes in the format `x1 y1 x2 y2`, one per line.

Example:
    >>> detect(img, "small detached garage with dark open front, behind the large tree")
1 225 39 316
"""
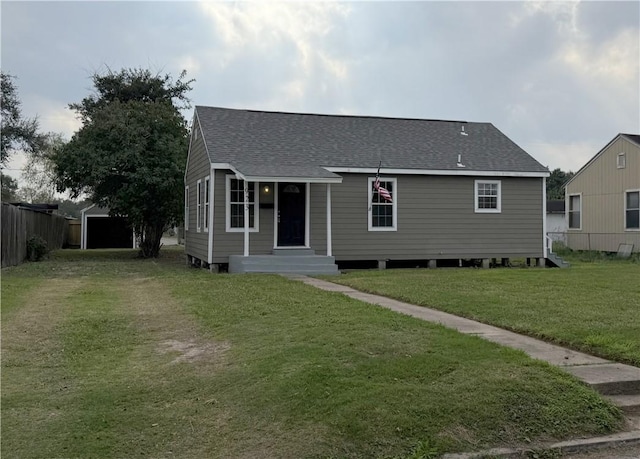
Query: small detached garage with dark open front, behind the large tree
80 204 136 249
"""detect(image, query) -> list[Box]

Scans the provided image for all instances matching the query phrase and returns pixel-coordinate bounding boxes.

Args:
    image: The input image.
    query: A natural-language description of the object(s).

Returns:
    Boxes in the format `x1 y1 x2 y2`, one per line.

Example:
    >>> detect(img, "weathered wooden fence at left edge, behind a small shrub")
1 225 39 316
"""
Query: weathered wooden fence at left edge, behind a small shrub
0 202 69 268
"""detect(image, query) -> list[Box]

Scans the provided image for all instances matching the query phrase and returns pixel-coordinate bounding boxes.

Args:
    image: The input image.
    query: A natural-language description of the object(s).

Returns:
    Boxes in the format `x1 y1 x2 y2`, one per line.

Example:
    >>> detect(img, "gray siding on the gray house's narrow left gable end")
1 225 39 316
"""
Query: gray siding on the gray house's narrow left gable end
184 122 211 262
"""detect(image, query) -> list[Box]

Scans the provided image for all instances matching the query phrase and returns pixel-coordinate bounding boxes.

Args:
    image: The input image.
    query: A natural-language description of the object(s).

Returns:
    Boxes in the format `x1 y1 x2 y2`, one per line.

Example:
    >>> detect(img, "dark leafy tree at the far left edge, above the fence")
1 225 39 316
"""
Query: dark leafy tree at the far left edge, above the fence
0 71 43 167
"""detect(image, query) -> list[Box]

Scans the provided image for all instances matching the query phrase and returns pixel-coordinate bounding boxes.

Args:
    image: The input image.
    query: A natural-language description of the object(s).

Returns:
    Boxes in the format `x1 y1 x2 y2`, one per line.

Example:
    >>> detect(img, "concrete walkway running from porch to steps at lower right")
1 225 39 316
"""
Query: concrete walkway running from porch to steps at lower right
285 275 640 457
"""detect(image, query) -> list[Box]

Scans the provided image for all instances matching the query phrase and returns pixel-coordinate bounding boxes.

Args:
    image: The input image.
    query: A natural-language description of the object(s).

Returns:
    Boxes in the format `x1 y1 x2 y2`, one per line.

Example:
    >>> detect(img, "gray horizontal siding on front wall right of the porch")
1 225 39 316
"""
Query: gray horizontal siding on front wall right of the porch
332 174 543 260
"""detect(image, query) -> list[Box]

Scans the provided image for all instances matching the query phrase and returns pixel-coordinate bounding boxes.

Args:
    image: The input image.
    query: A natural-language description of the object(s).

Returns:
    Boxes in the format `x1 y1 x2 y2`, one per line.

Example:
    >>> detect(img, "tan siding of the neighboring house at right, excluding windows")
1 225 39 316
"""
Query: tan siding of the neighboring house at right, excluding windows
566 137 640 251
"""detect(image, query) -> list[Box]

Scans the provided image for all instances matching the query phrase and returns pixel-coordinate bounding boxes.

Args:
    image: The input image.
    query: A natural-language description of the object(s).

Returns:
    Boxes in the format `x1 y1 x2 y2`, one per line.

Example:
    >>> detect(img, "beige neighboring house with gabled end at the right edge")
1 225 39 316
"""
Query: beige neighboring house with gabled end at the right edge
565 134 640 252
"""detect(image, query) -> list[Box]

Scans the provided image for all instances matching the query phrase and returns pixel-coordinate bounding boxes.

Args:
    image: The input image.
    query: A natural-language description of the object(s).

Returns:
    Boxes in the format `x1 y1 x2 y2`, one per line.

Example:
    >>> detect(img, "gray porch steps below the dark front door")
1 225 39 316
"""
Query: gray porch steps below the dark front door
229 248 338 275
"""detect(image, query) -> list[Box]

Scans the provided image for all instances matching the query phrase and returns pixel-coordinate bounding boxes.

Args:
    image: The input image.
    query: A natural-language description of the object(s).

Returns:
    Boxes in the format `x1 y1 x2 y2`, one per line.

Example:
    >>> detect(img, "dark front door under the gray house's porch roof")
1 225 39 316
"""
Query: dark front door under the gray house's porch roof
278 183 306 247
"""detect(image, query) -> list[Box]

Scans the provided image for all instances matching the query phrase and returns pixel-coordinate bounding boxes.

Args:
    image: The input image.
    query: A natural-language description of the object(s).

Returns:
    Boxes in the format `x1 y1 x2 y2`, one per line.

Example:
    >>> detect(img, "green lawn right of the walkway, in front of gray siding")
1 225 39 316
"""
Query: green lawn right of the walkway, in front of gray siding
328 254 640 365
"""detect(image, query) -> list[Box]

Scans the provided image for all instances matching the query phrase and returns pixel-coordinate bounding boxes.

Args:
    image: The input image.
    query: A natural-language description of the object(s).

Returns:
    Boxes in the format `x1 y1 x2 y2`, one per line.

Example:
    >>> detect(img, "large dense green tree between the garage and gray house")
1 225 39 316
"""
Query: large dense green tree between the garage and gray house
53 69 193 258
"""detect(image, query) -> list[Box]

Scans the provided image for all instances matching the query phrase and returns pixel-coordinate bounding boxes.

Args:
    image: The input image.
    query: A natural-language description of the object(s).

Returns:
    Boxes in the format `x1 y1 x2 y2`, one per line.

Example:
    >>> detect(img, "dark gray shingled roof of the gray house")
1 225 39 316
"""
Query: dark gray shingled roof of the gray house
196 106 548 177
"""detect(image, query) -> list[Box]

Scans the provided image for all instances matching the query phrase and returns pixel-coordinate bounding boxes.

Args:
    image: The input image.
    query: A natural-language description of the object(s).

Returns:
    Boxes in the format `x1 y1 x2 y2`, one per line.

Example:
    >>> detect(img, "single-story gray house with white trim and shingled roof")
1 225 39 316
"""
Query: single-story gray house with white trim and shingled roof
185 106 549 273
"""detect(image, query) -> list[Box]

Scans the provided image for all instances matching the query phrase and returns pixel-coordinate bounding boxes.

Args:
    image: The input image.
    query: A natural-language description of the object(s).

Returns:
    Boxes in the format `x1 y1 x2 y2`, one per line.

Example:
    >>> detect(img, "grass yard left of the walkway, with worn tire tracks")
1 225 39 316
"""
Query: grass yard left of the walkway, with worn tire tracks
2 250 623 458
